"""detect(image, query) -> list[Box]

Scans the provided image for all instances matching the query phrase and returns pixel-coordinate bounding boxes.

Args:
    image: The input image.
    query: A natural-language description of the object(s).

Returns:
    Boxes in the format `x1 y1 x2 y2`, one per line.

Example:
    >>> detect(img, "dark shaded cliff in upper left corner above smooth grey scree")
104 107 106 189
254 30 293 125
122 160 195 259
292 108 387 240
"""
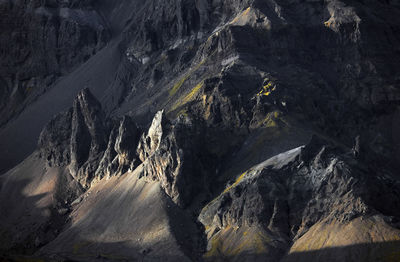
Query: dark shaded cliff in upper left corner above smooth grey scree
0 0 109 125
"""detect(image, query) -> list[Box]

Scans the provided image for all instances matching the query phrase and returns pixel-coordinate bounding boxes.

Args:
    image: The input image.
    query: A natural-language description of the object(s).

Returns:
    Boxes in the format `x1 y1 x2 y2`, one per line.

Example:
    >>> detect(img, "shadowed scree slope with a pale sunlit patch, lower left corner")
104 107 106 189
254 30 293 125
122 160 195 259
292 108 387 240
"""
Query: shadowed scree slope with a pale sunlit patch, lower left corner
0 158 74 261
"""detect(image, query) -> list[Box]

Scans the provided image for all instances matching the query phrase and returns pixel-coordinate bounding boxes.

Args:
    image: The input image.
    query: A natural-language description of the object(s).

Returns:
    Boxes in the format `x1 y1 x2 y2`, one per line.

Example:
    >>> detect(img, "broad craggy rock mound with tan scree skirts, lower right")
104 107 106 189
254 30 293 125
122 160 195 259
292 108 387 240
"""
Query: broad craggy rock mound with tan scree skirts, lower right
199 137 400 261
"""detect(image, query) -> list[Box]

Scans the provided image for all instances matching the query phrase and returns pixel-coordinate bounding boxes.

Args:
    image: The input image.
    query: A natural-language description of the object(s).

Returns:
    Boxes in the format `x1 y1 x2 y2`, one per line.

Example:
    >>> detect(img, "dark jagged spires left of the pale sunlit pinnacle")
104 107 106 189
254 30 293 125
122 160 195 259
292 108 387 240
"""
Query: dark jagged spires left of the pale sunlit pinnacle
38 89 144 189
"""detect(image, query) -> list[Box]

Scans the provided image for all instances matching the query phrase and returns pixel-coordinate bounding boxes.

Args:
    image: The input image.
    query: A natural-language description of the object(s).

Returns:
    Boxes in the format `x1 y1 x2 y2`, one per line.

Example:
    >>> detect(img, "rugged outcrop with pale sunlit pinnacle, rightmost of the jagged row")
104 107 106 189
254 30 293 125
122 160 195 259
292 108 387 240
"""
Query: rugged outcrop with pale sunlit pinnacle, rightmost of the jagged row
137 111 206 207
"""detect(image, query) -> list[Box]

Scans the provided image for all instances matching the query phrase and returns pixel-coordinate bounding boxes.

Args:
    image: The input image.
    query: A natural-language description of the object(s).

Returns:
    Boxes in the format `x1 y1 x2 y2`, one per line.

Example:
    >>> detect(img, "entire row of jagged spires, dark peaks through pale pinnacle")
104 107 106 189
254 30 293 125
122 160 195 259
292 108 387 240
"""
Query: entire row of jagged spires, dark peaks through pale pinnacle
39 93 204 206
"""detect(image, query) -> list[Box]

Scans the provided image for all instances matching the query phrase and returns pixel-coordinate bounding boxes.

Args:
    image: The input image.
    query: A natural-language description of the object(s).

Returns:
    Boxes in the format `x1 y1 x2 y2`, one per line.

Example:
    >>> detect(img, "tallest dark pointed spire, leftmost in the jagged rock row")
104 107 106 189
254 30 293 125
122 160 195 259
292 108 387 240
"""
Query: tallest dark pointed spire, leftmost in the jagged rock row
39 89 108 187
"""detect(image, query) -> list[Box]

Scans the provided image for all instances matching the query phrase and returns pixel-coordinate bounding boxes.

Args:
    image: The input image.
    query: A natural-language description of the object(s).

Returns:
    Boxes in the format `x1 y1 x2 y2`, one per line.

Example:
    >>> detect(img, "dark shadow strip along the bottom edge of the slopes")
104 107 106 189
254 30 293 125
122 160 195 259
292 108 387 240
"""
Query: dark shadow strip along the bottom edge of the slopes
0 241 400 262
